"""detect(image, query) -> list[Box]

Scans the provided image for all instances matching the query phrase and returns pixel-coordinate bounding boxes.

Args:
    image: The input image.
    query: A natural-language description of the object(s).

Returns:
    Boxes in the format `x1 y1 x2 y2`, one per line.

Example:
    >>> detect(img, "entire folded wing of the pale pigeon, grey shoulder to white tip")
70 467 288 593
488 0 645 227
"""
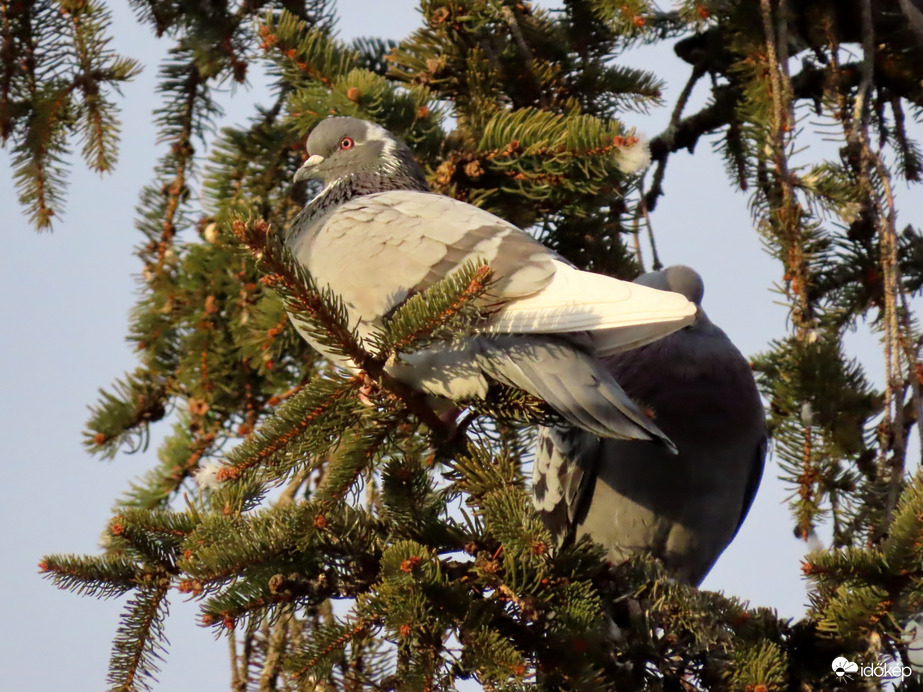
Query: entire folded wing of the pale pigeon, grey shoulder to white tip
306 191 695 340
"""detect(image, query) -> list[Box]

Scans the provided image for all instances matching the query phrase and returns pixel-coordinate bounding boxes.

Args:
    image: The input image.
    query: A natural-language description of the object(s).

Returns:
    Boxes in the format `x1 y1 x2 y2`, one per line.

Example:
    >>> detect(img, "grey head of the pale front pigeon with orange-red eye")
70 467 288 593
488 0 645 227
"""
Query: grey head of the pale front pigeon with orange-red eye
295 117 426 189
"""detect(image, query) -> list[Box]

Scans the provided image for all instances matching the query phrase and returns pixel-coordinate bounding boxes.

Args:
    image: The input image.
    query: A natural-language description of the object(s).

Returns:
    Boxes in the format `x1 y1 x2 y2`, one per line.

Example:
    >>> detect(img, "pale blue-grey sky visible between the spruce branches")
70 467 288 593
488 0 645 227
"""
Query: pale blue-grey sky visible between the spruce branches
0 0 923 692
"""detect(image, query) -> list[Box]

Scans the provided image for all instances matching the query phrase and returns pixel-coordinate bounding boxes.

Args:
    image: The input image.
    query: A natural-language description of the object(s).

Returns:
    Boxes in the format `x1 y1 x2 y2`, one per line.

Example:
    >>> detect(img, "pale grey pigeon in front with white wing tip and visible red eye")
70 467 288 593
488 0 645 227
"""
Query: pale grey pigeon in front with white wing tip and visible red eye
286 117 695 445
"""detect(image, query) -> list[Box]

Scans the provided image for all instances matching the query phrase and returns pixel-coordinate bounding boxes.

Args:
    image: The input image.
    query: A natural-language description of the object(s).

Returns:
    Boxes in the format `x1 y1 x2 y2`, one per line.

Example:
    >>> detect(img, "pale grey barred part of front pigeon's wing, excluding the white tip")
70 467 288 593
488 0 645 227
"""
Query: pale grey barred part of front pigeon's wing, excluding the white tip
304 191 555 322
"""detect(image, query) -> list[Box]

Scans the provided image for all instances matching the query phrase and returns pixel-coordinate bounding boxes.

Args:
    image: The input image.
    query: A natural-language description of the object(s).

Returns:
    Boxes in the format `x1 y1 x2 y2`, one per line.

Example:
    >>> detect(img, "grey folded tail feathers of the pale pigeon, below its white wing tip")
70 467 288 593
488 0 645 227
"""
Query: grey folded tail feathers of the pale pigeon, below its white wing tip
477 335 675 451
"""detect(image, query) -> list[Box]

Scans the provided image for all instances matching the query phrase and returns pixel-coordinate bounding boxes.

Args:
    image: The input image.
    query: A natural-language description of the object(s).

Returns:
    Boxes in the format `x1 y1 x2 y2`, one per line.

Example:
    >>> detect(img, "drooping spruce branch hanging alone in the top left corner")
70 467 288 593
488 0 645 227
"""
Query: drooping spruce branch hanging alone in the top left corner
0 0 139 230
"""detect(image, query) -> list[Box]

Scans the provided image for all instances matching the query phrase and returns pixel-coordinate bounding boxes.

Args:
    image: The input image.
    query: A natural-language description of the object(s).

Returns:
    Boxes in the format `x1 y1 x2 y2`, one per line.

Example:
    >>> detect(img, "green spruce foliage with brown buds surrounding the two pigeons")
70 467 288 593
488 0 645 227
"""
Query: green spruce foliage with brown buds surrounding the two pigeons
7 0 923 690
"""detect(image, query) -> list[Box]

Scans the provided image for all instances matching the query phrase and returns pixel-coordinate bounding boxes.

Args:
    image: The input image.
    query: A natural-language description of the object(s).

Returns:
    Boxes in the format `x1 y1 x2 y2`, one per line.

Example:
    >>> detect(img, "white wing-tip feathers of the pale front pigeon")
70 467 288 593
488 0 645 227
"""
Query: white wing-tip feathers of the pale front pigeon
485 260 696 355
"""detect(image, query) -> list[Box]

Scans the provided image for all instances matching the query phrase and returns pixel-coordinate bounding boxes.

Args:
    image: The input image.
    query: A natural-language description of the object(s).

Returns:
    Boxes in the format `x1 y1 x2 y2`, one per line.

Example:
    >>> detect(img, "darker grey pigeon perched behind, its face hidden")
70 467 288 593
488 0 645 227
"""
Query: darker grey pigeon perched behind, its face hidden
532 266 767 585
